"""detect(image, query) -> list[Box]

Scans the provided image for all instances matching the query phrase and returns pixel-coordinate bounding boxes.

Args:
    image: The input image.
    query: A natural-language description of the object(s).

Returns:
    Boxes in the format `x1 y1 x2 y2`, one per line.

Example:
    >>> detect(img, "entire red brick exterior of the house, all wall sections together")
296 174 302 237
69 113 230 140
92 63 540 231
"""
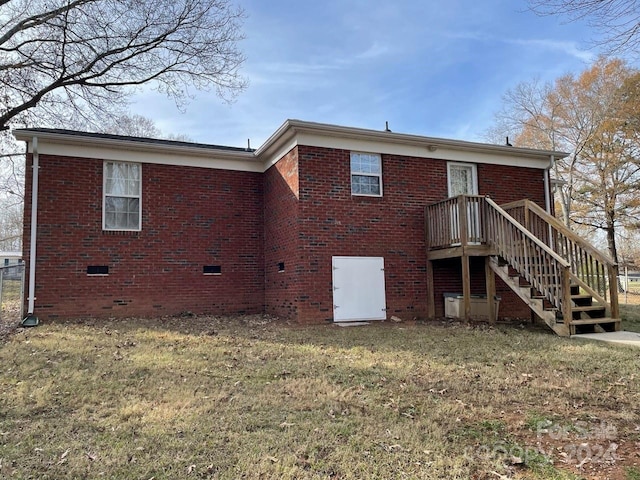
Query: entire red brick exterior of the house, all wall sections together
24 146 544 322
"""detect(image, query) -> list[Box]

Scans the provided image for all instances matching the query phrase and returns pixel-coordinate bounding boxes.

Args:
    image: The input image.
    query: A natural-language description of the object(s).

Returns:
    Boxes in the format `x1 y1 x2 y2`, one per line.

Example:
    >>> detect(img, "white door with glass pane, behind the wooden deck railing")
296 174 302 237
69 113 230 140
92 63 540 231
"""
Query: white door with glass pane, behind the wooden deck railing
447 163 480 244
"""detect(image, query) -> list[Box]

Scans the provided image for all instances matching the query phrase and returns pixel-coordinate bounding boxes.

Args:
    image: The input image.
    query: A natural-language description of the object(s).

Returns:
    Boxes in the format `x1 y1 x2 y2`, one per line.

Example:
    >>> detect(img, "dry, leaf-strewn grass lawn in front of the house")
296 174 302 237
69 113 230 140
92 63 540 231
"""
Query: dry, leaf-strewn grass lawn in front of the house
0 317 640 480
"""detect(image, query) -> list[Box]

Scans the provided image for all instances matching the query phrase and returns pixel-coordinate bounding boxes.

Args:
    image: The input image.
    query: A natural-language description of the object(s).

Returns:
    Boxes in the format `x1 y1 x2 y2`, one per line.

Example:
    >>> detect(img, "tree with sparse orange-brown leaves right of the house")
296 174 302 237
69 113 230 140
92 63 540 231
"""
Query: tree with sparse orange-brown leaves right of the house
484 57 640 261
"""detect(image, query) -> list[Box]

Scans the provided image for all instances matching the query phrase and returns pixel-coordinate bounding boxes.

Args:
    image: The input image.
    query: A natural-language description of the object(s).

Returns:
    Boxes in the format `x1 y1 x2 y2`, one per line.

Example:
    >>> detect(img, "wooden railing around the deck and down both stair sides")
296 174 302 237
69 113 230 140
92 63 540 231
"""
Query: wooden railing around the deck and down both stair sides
425 195 620 321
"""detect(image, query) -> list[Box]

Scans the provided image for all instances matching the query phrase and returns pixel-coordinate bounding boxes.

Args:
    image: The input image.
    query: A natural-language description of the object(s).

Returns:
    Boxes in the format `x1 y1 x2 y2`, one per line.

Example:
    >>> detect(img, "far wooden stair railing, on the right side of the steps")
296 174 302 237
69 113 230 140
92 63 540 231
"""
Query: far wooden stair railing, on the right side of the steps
502 200 620 323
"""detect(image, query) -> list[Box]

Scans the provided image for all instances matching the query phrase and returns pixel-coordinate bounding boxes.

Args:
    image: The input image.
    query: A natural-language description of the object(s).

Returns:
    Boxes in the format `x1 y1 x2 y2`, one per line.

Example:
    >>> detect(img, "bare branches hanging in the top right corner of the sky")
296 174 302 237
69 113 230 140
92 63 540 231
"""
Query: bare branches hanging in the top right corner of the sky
529 0 640 54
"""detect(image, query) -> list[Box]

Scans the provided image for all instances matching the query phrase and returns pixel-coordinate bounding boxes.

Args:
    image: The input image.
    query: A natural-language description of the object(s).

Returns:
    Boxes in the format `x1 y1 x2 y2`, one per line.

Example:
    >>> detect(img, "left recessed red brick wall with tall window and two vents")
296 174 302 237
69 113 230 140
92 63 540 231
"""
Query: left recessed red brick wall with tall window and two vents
24 155 264 319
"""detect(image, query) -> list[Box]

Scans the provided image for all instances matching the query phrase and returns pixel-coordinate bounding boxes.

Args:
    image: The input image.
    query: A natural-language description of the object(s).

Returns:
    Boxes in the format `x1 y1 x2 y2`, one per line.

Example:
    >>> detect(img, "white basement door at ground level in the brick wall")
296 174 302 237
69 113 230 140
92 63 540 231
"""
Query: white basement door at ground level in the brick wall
331 257 387 322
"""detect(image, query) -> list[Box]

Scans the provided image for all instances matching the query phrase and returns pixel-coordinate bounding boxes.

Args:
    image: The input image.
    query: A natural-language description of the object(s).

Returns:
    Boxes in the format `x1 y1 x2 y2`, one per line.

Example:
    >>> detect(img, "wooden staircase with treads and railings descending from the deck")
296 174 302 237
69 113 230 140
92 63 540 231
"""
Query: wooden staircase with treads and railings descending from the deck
426 196 621 336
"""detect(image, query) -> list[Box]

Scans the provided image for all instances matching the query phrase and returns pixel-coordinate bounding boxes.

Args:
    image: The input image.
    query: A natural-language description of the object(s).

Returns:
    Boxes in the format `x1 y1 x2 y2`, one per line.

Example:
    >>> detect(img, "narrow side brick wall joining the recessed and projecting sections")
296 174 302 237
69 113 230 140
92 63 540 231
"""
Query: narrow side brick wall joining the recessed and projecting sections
264 147 299 319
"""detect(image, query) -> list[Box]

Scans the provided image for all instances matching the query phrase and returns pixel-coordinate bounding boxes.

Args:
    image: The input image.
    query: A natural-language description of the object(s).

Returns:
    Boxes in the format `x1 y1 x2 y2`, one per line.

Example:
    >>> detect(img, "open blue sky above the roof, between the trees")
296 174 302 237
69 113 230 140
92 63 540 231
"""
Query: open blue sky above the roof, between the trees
131 0 598 147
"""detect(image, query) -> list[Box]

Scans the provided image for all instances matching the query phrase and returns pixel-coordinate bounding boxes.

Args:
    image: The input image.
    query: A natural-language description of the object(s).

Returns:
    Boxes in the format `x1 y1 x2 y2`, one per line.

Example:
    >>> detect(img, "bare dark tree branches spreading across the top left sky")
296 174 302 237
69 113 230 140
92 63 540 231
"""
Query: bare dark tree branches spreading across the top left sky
0 0 245 129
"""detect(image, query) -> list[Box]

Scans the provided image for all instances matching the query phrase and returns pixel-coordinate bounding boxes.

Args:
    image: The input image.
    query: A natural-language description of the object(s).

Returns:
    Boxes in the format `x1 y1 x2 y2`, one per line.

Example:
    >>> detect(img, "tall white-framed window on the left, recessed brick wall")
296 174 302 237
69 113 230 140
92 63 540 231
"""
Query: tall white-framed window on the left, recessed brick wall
102 162 142 231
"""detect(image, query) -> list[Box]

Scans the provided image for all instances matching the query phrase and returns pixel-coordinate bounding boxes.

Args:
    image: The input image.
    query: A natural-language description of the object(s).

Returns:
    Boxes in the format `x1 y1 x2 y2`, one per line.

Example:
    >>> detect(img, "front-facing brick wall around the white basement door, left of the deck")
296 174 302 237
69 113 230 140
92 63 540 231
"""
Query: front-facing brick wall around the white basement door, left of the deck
292 146 446 322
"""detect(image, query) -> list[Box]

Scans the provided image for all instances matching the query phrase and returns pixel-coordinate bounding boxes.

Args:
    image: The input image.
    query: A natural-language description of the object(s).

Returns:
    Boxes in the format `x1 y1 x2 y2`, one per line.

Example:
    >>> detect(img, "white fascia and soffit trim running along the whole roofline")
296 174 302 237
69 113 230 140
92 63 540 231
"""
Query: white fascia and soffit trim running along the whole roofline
14 120 567 172
